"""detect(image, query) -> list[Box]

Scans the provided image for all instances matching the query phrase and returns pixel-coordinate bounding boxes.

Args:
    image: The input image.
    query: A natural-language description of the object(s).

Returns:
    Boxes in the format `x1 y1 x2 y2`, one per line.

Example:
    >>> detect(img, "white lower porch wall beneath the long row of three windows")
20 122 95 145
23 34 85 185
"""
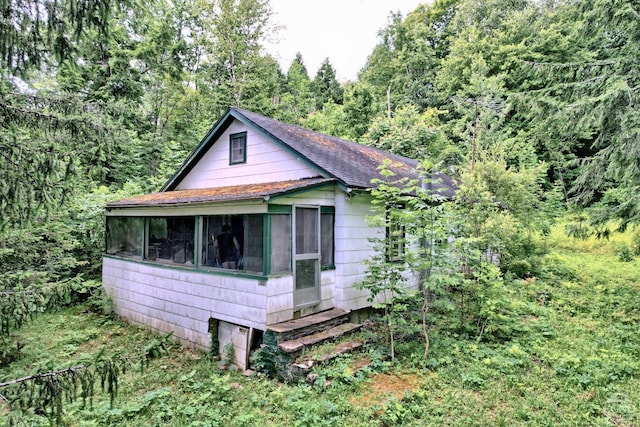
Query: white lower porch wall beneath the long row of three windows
102 257 267 349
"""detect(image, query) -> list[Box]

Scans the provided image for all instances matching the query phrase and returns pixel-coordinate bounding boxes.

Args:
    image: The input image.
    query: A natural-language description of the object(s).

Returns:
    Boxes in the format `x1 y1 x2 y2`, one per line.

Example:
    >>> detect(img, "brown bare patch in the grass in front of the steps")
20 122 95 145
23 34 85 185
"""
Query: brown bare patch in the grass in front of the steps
350 374 422 408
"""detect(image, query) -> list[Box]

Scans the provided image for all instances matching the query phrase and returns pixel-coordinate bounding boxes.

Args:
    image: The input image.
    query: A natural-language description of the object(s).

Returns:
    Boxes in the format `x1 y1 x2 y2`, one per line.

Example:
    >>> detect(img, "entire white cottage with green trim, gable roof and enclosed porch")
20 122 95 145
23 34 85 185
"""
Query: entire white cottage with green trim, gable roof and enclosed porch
103 108 453 367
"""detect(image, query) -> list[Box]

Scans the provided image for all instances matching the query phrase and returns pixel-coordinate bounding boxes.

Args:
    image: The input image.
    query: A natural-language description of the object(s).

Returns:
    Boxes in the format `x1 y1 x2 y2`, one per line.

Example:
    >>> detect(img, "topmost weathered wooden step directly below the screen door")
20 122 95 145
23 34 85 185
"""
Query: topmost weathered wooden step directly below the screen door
267 308 349 342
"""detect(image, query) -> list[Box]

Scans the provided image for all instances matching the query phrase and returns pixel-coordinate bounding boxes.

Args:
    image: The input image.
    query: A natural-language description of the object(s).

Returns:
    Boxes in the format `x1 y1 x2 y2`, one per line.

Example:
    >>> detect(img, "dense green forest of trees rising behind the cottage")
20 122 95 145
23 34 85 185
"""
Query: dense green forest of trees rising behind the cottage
0 0 640 424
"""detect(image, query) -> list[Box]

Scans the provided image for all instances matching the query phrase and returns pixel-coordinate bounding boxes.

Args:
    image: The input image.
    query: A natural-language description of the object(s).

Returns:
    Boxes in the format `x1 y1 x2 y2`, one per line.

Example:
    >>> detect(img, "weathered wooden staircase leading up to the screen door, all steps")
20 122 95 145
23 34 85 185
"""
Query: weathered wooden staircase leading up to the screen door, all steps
267 308 364 378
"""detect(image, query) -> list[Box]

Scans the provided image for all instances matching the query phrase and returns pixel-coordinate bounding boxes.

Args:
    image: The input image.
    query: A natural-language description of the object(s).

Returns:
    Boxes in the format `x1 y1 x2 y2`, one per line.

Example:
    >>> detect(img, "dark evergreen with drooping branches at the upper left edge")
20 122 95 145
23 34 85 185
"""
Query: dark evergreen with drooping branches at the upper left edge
0 0 129 229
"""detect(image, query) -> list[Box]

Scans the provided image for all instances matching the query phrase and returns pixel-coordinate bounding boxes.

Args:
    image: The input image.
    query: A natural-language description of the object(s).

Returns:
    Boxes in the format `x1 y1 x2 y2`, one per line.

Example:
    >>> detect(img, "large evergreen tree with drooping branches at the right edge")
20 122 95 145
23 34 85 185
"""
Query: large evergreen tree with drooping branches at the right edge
542 0 640 228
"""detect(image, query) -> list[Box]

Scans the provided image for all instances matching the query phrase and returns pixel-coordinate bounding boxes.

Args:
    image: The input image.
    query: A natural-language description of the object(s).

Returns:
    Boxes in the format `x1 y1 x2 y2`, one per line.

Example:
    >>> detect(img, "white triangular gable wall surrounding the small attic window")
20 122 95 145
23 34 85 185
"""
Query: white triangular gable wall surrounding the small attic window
176 120 320 190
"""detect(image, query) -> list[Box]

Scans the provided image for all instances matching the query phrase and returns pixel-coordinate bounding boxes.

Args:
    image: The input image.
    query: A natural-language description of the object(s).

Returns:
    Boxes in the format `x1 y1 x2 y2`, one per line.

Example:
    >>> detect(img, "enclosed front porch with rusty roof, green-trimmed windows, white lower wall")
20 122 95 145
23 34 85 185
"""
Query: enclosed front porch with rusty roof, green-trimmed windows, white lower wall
103 178 352 364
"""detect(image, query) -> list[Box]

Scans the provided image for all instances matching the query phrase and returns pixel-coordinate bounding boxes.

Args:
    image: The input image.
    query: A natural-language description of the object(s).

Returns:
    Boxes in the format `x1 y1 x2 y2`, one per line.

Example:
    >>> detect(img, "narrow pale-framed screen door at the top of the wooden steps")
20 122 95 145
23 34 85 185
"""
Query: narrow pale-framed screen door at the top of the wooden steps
293 206 321 308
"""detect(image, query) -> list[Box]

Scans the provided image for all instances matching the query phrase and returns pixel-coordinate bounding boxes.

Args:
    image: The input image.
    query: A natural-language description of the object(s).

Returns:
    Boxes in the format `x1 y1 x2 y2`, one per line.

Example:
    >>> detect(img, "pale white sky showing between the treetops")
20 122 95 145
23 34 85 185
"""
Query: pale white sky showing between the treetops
267 0 425 82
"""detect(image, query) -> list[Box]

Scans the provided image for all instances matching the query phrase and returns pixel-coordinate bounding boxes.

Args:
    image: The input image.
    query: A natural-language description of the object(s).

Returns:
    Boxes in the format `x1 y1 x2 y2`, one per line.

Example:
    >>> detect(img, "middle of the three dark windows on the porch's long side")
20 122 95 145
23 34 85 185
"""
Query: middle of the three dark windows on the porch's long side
146 217 195 265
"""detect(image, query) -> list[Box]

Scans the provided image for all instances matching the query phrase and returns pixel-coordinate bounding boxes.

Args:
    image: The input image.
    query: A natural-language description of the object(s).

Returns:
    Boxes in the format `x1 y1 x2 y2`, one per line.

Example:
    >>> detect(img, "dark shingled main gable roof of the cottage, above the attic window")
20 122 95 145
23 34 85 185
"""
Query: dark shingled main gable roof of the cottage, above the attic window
161 107 455 198
